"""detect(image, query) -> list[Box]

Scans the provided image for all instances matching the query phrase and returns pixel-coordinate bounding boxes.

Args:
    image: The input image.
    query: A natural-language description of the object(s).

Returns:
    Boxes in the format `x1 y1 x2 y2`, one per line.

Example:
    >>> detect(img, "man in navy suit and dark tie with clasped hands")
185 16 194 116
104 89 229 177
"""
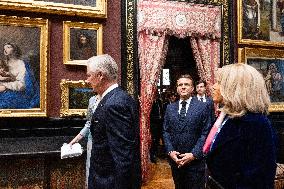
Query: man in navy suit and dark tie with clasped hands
163 75 211 189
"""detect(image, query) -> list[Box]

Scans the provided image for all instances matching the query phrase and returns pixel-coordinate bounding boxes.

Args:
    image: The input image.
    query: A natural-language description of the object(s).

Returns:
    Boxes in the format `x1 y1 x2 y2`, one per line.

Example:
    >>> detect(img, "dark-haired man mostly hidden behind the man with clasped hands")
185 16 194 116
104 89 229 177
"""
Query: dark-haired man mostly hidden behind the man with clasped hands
195 80 215 121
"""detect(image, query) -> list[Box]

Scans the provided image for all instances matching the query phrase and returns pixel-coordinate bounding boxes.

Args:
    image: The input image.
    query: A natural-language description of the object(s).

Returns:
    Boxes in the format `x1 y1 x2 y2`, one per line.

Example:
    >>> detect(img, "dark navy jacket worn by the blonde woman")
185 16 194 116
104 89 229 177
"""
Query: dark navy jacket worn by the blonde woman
206 113 276 189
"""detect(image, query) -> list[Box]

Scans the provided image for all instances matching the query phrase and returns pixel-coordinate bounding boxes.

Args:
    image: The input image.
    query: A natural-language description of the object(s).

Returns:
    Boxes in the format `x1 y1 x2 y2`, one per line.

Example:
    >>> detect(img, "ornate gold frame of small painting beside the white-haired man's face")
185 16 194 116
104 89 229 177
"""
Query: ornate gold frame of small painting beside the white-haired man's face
60 79 92 117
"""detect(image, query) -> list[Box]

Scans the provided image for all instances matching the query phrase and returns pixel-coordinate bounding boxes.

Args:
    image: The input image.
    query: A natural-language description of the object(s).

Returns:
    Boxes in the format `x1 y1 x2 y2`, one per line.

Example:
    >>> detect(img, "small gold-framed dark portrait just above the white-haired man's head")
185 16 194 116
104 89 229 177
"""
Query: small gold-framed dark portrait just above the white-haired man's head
63 21 103 65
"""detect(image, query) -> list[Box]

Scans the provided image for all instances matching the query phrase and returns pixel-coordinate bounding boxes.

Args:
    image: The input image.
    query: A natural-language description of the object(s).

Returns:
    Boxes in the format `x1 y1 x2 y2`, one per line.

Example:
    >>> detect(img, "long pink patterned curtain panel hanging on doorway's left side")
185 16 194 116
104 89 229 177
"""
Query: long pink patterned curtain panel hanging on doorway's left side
138 31 168 180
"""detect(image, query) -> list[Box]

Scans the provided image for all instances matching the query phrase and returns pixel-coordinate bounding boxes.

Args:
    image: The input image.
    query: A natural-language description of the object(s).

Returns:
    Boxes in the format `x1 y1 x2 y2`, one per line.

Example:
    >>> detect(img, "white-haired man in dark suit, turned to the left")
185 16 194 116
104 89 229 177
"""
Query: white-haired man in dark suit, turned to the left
87 55 141 189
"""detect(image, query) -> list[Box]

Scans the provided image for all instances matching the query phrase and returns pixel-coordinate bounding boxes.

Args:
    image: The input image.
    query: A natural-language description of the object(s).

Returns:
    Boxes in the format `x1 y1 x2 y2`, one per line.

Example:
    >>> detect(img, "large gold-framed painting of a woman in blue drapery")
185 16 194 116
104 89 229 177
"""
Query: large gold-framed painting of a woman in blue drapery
0 15 49 117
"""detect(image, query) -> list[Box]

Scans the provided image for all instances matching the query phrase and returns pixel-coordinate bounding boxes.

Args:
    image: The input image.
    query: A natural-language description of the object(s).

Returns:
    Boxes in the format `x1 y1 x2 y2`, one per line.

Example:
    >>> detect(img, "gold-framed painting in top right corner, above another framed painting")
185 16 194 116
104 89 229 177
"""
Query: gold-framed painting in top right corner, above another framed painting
237 0 284 47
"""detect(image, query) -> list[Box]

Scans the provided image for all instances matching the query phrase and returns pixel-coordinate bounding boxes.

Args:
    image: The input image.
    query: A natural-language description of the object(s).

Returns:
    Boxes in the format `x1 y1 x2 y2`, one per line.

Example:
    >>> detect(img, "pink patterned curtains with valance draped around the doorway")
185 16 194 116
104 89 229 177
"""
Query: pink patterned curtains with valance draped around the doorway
138 1 222 180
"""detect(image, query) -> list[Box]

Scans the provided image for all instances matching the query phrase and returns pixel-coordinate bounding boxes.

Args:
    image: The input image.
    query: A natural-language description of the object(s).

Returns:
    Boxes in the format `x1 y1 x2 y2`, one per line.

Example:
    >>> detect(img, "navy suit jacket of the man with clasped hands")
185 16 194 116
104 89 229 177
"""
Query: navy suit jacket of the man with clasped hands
163 97 211 168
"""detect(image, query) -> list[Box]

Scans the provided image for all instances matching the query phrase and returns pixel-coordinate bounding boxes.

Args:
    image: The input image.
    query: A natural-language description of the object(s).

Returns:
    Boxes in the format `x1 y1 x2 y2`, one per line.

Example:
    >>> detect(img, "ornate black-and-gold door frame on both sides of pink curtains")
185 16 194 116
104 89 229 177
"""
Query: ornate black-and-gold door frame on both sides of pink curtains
121 0 234 98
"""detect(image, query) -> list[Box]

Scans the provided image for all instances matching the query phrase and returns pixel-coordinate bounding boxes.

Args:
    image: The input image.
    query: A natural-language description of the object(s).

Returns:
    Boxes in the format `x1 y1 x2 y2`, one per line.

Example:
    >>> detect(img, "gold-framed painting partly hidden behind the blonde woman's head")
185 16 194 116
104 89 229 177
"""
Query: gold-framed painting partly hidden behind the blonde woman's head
238 47 284 112
